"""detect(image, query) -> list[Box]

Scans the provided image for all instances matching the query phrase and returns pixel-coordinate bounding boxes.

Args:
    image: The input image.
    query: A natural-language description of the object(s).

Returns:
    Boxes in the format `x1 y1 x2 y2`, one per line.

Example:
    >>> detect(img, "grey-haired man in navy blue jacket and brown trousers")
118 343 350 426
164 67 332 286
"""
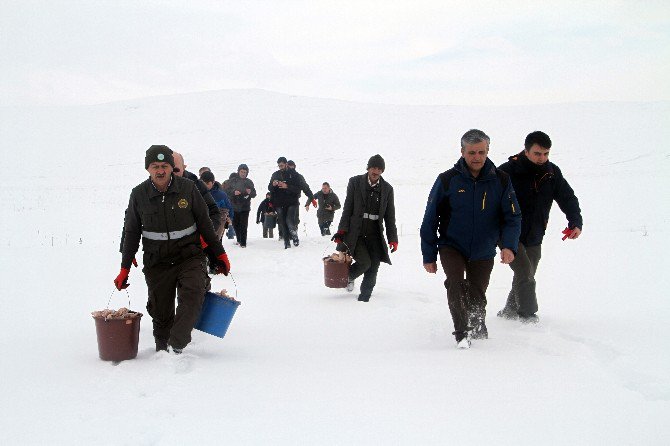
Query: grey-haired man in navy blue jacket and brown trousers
421 130 521 348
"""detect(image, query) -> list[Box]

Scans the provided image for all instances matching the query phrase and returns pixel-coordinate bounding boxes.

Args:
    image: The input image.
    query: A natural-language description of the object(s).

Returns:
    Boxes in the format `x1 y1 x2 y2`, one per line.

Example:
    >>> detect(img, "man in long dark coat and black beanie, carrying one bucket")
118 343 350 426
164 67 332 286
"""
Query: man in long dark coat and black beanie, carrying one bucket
332 155 398 302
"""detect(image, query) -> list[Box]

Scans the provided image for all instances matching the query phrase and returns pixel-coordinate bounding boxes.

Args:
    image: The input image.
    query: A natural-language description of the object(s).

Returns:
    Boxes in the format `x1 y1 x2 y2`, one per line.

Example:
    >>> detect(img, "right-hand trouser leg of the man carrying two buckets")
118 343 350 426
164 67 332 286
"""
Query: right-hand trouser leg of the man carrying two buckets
169 256 209 348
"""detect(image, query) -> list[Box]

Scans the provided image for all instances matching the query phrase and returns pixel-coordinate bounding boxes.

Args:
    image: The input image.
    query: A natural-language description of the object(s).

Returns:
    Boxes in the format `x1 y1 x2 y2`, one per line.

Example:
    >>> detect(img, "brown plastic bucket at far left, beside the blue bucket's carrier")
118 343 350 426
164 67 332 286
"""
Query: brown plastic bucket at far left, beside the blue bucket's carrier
93 313 142 361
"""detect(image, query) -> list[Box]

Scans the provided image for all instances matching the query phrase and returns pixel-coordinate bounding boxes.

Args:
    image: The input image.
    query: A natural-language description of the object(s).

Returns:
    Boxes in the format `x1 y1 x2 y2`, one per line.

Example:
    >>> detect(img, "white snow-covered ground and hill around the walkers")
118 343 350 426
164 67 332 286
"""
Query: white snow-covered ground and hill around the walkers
0 90 670 445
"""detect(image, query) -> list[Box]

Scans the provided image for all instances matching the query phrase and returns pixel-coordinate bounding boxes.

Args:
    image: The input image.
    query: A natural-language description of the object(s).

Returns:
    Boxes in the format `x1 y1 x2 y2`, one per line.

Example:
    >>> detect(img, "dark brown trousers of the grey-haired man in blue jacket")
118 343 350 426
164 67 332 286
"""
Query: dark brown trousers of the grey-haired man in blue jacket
440 246 493 331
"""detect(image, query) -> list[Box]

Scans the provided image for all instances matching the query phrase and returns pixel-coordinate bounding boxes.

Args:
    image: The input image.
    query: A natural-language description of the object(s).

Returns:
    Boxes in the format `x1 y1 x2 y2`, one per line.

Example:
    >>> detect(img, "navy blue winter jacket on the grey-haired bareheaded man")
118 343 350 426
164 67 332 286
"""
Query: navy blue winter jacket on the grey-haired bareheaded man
421 158 521 263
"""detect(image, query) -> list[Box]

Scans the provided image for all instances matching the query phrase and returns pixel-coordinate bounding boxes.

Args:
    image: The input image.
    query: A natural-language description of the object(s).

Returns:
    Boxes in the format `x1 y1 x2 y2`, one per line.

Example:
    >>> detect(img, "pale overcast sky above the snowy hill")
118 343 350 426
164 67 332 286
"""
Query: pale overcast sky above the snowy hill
0 0 670 105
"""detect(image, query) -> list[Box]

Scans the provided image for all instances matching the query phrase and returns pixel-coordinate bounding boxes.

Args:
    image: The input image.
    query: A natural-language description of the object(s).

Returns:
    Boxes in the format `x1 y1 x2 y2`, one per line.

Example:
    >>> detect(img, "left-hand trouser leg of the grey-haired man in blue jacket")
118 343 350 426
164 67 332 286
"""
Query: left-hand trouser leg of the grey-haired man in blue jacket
440 247 471 332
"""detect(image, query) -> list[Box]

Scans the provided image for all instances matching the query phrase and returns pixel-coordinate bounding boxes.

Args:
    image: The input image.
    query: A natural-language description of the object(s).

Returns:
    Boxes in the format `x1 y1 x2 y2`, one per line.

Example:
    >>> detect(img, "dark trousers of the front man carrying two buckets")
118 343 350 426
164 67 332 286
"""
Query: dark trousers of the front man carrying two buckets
143 254 209 348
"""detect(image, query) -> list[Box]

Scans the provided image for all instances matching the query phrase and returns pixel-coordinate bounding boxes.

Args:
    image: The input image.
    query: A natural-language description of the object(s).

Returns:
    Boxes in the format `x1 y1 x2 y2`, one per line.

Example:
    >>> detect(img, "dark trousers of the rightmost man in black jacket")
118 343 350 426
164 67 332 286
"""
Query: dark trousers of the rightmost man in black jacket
505 243 542 316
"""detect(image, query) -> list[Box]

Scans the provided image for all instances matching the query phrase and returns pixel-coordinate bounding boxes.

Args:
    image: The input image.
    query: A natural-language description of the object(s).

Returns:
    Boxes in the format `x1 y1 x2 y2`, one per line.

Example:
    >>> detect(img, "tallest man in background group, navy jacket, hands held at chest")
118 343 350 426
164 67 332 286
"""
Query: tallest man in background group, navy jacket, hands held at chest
268 156 302 249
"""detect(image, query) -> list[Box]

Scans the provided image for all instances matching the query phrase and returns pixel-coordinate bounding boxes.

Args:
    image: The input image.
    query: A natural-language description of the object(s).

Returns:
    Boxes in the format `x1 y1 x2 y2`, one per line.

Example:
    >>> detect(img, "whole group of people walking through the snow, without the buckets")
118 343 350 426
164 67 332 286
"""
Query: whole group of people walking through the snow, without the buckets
114 129 582 353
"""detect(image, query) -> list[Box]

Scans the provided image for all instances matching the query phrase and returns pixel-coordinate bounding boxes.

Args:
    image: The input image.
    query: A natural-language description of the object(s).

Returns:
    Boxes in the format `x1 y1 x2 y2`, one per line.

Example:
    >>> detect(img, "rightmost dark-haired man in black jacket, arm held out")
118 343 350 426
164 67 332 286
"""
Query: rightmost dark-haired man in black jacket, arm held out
498 131 582 323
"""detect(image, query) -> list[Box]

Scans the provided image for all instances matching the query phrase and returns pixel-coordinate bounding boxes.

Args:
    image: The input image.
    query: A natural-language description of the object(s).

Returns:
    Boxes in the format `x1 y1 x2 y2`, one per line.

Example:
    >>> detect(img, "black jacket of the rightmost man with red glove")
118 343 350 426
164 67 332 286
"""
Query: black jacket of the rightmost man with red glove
498 152 582 246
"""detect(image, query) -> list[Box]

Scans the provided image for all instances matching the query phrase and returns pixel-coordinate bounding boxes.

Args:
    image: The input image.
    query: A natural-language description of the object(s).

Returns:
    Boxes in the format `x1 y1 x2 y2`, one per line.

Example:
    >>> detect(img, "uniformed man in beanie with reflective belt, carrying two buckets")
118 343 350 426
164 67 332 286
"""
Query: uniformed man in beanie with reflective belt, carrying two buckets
114 145 230 353
